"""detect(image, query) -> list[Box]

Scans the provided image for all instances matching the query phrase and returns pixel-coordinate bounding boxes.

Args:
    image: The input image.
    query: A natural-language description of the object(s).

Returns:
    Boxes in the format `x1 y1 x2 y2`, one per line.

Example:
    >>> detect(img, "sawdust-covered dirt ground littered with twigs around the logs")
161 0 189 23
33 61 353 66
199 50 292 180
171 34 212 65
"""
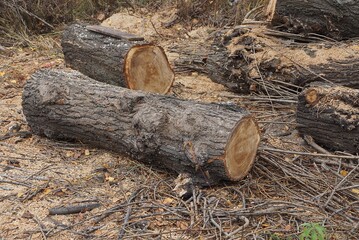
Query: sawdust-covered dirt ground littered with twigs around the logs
0 9 359 239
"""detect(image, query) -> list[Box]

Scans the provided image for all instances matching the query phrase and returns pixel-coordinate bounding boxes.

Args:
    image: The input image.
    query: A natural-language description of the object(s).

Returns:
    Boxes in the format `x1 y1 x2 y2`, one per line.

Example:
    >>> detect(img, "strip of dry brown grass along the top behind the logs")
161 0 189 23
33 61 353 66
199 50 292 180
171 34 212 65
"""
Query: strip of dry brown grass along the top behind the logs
0 0 266 46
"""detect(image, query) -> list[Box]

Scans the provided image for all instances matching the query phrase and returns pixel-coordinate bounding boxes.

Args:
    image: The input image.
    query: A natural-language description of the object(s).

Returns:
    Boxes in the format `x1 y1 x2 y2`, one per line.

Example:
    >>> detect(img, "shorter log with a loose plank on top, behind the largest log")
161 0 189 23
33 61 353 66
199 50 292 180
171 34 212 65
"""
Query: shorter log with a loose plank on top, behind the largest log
61 24 174 94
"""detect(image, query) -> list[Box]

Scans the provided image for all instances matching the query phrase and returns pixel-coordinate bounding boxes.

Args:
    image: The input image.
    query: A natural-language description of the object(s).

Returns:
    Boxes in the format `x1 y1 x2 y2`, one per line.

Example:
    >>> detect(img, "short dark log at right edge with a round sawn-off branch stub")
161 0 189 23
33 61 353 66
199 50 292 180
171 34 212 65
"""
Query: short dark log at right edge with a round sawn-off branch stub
297 84 359 154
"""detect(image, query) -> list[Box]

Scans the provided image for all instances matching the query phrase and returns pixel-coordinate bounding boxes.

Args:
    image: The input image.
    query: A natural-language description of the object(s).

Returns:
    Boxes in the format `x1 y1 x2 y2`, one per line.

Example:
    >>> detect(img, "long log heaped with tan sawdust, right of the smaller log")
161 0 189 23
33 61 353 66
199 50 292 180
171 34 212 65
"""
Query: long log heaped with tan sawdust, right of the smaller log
172 28 359 96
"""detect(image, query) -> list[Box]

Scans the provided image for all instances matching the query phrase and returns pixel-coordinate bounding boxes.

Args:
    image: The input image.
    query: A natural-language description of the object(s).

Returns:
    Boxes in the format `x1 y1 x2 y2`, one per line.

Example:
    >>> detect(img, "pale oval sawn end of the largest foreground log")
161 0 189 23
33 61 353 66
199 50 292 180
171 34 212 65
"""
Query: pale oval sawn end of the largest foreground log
225 118 260 180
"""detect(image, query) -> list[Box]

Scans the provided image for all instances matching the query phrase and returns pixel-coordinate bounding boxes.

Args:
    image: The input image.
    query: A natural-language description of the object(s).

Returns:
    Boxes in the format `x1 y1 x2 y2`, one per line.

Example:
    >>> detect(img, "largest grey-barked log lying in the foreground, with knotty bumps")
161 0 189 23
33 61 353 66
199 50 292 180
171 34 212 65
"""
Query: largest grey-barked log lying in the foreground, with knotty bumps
22 70 260 185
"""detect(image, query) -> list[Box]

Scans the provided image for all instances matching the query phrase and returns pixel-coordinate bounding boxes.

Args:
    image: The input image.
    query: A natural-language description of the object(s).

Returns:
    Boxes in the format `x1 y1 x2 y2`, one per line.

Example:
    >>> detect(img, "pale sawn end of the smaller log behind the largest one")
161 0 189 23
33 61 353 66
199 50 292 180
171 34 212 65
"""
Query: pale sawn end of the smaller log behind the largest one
124 45 174 94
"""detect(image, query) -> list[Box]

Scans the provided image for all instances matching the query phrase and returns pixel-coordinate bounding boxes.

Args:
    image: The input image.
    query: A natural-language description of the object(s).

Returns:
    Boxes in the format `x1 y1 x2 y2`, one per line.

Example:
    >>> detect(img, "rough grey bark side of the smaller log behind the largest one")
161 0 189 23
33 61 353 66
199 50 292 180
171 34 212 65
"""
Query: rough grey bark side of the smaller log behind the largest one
61 24 145 87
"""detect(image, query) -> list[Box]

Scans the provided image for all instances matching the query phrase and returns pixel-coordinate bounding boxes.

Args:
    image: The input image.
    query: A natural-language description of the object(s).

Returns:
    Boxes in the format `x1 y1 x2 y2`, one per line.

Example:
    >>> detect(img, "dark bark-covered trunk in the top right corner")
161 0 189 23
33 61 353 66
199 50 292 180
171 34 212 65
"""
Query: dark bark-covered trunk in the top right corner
272 0 359 40
